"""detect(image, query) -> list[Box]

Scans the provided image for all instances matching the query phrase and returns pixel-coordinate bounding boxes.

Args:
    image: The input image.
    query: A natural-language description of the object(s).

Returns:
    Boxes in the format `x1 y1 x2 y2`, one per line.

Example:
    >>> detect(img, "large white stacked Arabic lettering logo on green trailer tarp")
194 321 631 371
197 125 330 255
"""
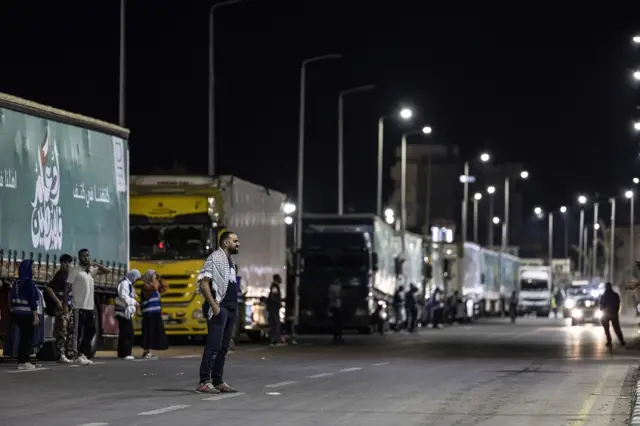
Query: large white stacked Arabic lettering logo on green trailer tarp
31 131 62 250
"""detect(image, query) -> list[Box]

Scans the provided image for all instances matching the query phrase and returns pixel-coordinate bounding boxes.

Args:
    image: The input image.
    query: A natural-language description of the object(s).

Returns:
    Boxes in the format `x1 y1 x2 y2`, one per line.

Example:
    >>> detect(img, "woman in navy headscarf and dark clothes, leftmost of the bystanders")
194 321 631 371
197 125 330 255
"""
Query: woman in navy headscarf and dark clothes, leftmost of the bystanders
11 259 40 370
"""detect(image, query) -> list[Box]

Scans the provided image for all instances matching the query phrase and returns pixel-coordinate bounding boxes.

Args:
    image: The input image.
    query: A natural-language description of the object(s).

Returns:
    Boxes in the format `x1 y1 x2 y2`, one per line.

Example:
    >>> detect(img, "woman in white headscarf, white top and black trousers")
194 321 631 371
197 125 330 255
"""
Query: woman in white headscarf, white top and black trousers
116 269 142 360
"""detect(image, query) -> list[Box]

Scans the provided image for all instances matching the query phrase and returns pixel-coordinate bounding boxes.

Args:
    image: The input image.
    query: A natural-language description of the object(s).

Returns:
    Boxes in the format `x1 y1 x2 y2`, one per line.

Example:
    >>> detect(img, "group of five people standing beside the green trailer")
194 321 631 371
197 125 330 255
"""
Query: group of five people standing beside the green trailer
5 249 168 370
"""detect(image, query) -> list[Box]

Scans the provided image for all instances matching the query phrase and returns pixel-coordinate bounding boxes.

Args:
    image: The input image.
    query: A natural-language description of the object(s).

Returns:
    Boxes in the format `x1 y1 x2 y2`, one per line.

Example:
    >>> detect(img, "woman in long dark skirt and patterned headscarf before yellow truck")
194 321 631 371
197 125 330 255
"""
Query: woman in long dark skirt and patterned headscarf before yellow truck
140 269 169 359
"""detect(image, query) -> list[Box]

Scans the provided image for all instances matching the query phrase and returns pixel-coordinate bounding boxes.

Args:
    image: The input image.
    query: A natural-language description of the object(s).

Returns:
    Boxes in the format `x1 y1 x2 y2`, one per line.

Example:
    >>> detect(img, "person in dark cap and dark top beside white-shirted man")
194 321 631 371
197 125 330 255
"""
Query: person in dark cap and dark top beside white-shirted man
43 254 74 364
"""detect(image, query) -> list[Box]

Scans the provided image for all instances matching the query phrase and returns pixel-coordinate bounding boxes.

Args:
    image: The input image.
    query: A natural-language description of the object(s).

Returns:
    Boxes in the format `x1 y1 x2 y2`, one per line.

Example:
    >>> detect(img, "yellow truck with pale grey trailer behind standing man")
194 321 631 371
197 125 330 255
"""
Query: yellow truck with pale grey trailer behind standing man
129 175 287 340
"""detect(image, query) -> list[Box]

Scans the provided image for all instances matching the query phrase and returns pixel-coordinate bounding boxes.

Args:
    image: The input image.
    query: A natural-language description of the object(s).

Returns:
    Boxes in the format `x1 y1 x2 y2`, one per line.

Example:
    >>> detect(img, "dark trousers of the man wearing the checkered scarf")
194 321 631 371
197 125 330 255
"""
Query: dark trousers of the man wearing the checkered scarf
200 306 237 386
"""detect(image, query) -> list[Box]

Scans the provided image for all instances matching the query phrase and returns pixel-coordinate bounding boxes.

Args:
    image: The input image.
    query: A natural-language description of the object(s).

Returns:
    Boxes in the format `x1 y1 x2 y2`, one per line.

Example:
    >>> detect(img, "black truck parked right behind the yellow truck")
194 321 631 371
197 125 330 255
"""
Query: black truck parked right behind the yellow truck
298 214 397 334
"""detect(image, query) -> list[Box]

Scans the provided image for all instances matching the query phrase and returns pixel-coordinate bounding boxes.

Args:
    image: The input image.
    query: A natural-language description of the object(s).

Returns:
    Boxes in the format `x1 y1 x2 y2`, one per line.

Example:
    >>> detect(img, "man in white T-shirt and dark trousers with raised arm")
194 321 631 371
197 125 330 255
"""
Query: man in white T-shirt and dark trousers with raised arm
67 249 109 365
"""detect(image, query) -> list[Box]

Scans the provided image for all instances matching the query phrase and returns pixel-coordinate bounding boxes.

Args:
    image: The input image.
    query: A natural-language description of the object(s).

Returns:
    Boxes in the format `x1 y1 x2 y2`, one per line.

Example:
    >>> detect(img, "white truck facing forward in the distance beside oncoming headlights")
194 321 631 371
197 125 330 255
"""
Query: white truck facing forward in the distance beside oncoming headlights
518 263 553 316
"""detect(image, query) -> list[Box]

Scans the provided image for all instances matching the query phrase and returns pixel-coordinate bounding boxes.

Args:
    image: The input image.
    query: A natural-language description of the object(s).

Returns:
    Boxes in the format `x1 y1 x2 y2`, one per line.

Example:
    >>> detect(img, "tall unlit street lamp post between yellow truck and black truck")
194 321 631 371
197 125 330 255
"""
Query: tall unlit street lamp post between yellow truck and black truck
296 53 342 339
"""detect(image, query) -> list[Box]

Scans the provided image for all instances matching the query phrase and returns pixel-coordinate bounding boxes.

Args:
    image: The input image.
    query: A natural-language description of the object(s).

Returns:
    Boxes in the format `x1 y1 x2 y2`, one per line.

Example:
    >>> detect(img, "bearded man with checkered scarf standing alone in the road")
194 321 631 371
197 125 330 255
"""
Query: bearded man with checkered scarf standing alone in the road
196 231 240 394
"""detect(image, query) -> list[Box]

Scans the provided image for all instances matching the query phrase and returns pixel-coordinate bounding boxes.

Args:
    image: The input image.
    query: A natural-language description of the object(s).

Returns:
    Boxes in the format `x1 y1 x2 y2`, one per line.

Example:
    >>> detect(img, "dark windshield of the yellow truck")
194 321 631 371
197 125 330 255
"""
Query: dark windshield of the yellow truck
130 224 208 260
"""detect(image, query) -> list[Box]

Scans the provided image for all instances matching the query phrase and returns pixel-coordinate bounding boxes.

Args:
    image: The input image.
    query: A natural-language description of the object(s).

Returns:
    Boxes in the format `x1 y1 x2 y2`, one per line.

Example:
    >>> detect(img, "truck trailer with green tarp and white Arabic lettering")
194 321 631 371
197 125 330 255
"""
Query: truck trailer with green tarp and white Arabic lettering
0 94 129 359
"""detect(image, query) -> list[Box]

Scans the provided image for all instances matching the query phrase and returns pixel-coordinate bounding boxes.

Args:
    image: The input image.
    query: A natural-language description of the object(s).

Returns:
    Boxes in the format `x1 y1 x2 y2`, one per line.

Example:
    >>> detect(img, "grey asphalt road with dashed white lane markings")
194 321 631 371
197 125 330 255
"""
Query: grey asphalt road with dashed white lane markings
0 318 640 426
